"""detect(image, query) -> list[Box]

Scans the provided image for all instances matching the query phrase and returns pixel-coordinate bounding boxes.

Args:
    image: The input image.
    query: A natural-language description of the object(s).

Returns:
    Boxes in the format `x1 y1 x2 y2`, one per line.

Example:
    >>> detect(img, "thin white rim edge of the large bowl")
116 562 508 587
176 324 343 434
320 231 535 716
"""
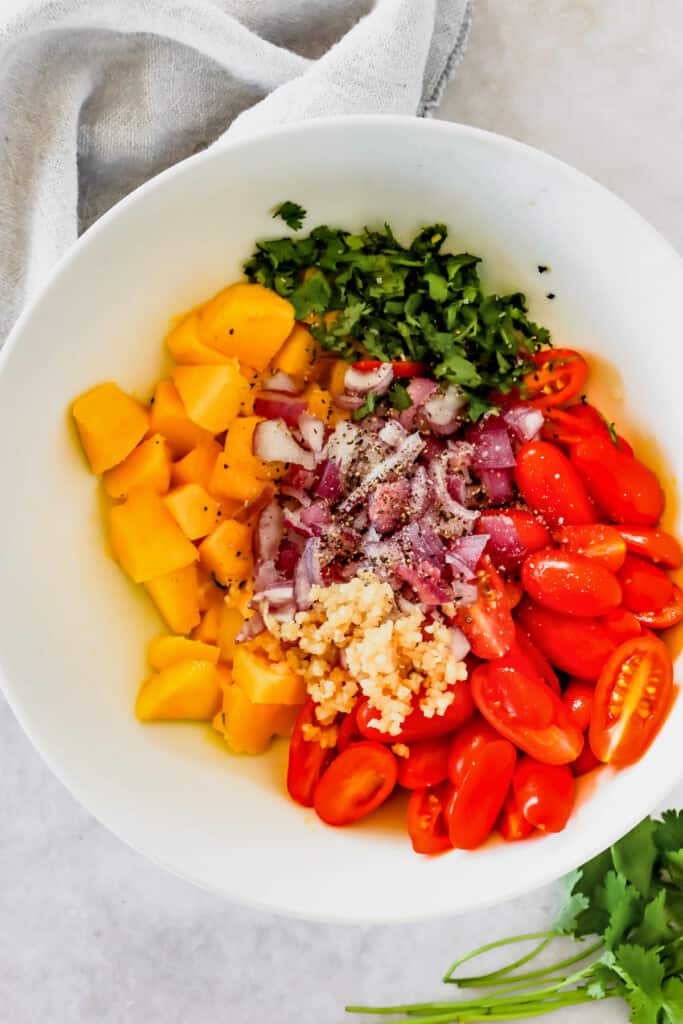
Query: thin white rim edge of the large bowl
0 114 683 925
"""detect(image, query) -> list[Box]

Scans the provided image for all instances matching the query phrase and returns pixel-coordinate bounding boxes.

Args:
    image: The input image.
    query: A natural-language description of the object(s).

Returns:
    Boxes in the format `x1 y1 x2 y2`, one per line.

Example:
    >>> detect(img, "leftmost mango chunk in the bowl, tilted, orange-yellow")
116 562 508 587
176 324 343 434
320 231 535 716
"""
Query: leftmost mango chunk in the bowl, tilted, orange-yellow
72 381 150 473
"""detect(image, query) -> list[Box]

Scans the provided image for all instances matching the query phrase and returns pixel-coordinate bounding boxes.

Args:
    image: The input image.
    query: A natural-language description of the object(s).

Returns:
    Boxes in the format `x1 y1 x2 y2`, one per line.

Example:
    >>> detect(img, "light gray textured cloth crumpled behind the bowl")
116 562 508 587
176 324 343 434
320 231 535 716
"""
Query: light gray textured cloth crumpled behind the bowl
0 0 471 341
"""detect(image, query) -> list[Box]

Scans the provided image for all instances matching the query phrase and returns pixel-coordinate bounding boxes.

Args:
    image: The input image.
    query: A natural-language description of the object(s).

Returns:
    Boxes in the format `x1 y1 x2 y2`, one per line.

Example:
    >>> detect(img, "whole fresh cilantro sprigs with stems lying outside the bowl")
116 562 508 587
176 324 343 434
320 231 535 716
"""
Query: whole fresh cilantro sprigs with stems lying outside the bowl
346 811 683 1024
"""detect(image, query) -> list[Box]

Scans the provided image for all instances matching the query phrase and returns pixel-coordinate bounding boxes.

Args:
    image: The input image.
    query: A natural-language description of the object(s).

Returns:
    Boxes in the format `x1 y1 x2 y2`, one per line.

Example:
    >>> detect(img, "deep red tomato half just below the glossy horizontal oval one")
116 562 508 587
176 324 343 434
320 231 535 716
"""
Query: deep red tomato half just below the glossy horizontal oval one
516 600 618 679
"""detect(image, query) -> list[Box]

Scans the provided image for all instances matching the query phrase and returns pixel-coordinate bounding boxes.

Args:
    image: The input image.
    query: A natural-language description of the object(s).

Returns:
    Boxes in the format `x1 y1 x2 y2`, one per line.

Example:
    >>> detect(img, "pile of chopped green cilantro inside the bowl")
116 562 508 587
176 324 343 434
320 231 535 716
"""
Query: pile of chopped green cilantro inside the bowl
245 222 550 420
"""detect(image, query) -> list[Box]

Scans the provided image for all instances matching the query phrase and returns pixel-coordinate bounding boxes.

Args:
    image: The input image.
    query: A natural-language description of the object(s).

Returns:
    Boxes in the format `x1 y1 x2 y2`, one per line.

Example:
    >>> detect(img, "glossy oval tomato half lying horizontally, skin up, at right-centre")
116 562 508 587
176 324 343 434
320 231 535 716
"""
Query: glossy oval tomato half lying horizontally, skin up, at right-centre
522 548 622 617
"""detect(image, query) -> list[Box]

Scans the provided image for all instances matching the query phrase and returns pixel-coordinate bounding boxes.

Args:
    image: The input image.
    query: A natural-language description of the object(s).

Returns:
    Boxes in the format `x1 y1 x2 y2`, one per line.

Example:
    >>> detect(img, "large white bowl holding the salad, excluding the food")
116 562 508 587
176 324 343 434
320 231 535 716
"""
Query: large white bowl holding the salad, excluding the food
0 118 683 921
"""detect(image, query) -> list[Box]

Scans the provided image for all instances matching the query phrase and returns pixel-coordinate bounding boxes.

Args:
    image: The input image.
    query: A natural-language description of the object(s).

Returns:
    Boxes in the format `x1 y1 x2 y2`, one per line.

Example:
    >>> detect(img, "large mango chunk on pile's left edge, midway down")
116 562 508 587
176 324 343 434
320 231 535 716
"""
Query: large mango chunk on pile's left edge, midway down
110 487 199 583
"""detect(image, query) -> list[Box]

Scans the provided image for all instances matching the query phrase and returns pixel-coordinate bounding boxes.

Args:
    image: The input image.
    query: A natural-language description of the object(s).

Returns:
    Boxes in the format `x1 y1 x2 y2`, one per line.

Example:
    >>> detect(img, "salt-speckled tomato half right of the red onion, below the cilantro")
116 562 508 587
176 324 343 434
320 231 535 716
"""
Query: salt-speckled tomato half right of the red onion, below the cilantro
515 441 596 527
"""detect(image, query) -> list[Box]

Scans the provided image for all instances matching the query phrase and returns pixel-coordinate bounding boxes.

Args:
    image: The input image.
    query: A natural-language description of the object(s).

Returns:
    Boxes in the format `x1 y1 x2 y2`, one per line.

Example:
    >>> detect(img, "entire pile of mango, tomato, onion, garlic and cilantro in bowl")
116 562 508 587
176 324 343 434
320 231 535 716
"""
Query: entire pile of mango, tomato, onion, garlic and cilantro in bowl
73 211 683 854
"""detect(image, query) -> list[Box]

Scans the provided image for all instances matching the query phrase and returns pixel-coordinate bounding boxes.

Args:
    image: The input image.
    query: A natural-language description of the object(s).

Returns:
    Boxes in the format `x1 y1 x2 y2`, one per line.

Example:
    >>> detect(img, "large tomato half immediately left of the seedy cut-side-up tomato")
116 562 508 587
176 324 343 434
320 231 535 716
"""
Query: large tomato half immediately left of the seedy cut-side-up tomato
471 663 584 765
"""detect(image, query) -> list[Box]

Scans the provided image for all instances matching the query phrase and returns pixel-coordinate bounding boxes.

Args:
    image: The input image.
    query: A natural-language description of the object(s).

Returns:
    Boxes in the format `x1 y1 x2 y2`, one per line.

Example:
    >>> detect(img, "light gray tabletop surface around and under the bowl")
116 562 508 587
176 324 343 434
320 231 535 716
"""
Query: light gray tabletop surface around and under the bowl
5 0 683 1024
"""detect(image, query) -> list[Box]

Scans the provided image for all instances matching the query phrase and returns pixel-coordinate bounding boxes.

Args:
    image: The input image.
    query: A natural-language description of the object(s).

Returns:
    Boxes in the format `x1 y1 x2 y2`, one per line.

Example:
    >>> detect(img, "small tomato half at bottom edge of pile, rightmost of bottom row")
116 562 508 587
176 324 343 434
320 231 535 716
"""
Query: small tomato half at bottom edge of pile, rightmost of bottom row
512 758 574 833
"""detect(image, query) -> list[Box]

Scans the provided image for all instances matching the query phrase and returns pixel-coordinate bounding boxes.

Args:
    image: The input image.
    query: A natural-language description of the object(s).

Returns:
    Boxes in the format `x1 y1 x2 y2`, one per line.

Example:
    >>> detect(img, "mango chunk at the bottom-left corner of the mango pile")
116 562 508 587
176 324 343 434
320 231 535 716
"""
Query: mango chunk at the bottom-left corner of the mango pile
135 660 223 722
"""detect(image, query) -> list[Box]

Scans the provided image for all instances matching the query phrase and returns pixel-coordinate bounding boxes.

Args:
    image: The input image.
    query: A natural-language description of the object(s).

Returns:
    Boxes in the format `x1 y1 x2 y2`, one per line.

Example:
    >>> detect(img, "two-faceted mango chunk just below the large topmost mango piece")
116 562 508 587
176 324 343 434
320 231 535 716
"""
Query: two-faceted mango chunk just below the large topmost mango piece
173 359 249 434
